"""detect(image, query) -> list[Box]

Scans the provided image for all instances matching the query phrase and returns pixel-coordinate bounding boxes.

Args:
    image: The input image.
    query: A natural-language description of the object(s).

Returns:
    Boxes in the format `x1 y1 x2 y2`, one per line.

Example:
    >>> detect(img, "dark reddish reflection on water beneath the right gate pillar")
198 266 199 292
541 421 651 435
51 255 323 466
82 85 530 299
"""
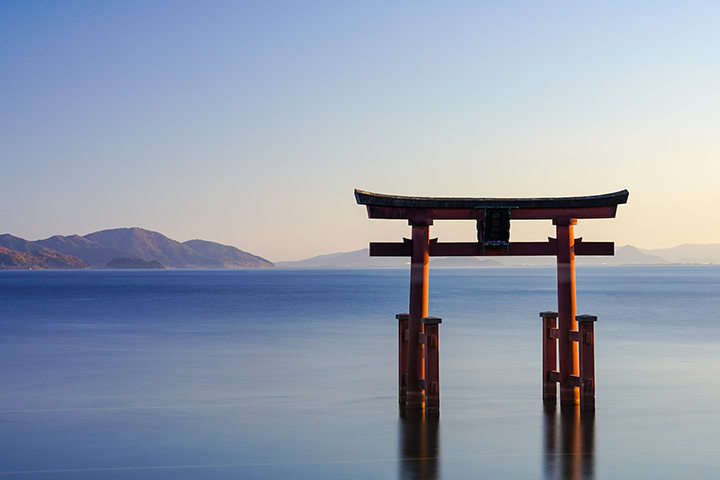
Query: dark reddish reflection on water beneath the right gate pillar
543 405 595 480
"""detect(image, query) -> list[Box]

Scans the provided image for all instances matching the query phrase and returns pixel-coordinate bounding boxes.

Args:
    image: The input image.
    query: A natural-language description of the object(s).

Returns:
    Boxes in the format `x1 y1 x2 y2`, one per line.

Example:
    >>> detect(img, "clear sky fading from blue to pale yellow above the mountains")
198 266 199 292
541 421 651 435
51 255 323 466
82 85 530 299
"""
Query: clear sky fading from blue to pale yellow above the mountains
0 0 720 261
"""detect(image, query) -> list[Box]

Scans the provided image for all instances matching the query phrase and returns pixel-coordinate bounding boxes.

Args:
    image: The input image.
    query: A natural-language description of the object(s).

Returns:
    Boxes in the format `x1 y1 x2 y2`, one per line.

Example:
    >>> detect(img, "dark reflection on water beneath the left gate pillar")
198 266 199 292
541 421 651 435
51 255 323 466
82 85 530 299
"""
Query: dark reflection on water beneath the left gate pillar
398 409 440 480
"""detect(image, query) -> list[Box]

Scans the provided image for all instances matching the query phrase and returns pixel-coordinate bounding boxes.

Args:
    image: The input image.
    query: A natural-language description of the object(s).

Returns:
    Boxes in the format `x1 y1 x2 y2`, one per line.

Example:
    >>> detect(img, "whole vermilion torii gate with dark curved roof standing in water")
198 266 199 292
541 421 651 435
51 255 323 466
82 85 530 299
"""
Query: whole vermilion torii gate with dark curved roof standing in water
355 189 629 410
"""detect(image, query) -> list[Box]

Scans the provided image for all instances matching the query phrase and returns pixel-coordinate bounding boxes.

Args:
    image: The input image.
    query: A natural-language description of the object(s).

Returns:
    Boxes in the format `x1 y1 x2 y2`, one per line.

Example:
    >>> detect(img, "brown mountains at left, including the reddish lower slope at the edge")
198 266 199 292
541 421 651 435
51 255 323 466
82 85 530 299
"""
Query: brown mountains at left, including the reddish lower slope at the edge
0 228 275 269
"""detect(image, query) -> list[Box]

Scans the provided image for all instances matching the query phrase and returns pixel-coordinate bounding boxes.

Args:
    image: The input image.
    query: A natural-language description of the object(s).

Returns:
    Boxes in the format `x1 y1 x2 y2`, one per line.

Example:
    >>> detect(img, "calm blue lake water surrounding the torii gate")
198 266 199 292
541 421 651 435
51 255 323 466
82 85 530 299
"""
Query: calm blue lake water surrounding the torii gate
0 266 720 479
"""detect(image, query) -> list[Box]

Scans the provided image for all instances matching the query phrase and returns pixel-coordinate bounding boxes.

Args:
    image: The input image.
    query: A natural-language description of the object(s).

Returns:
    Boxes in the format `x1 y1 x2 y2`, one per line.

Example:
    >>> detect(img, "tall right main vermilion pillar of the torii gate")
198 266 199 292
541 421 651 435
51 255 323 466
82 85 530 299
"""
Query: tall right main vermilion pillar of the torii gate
553 218 579 405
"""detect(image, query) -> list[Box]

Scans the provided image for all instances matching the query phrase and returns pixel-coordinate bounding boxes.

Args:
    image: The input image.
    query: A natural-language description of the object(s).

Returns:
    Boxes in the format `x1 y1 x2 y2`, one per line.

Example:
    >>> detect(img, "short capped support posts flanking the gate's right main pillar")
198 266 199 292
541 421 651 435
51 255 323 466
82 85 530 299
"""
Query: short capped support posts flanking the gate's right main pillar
540 312 597 410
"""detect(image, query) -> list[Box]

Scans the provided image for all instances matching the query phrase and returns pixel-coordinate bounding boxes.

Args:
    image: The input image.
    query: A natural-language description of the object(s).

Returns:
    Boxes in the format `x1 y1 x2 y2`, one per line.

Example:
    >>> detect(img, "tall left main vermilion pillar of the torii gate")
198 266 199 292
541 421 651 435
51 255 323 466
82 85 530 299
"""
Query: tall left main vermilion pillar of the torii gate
405 219 432 408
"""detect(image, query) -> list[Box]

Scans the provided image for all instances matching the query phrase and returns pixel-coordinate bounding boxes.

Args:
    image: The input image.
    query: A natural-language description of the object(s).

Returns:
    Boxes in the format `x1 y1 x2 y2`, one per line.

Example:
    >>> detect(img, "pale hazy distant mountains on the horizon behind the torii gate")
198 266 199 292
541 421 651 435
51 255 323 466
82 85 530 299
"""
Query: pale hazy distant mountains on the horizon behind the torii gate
276 244 720 268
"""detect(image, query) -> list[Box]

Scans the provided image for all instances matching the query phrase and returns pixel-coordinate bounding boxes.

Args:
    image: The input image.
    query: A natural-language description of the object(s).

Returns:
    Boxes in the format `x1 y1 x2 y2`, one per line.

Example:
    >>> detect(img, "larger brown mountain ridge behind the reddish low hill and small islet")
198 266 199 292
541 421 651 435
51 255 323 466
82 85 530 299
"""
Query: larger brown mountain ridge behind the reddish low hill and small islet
0 228 274 268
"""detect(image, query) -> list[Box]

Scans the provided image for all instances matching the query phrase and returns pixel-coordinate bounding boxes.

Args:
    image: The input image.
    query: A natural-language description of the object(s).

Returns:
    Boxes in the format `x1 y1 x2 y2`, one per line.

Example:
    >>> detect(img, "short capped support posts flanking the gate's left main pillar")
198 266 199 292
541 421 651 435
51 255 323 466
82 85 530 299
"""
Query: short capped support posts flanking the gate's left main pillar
395 313 442 414
